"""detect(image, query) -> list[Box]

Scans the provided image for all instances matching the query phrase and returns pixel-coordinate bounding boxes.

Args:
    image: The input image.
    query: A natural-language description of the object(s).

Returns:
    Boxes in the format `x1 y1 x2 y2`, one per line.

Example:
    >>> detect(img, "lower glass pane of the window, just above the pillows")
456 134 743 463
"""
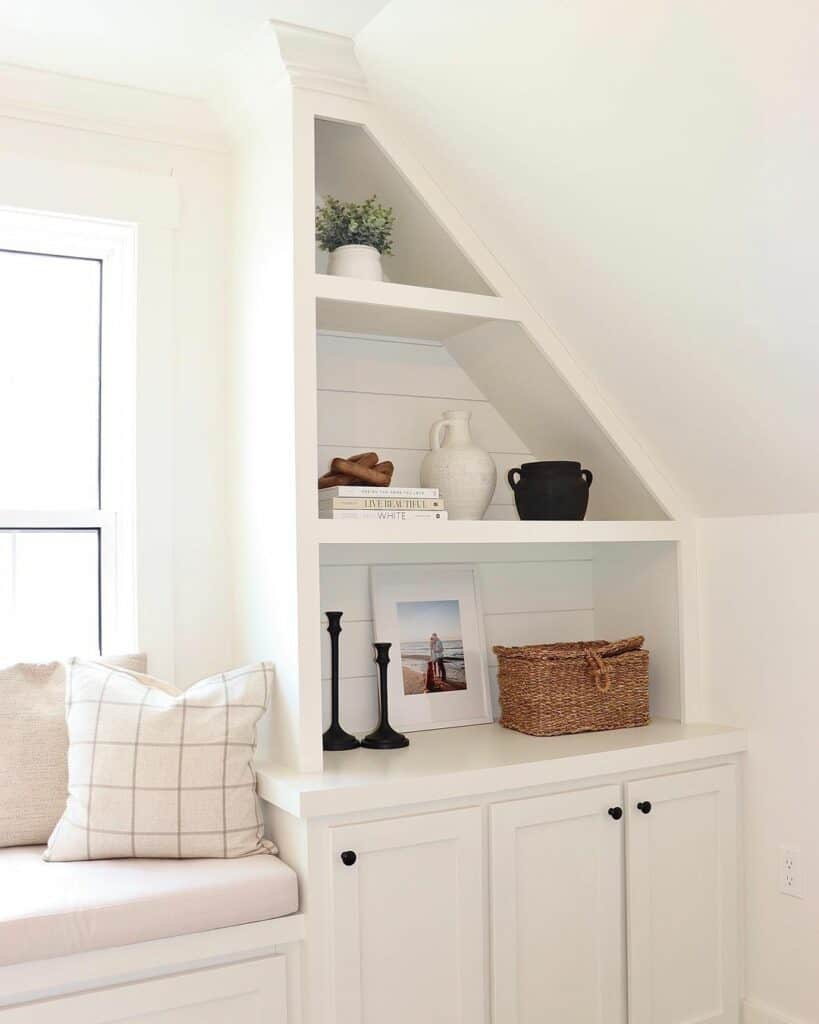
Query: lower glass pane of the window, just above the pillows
0 529 99 663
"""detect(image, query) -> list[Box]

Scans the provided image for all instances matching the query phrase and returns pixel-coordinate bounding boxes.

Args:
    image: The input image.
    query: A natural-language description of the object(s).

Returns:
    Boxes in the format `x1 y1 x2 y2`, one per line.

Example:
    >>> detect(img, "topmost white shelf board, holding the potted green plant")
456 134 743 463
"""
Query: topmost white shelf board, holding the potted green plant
313 273 520 340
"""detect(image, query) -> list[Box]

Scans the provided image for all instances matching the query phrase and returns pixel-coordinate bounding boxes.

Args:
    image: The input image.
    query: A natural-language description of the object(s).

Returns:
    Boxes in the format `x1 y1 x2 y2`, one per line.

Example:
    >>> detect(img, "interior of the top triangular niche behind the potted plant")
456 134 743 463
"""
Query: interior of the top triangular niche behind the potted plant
315 119 494 295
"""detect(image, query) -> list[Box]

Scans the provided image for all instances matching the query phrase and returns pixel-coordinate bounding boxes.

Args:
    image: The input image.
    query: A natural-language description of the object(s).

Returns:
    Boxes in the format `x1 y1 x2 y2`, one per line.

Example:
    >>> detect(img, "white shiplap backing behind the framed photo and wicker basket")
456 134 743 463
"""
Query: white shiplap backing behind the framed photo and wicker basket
318 549 595 733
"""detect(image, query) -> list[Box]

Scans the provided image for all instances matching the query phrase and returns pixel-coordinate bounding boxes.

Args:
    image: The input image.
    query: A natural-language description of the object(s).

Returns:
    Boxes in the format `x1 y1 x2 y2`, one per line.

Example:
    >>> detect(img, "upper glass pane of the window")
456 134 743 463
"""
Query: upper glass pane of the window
0 250 102 509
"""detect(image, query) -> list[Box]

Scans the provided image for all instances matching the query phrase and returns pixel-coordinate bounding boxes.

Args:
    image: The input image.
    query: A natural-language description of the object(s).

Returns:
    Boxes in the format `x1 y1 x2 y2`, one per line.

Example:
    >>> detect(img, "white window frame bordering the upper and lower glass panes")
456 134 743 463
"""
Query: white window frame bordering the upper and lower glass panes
0 209 139 654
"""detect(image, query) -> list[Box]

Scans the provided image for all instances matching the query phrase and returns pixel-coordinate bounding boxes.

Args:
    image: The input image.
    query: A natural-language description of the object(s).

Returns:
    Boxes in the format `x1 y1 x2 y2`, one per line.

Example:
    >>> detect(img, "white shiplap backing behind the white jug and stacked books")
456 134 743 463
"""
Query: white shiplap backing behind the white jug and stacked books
316 333 533 519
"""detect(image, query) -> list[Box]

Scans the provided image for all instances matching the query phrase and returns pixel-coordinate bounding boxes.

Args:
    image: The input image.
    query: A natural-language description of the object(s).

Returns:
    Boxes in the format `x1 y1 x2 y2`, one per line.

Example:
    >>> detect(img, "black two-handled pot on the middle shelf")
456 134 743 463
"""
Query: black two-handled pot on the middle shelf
507 462 593 519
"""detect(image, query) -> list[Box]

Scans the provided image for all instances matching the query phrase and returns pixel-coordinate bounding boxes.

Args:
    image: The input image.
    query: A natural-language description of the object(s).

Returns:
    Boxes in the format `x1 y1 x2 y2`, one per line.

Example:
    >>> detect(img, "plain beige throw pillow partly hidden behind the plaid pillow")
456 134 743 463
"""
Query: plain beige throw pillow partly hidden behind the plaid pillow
0 654 145 847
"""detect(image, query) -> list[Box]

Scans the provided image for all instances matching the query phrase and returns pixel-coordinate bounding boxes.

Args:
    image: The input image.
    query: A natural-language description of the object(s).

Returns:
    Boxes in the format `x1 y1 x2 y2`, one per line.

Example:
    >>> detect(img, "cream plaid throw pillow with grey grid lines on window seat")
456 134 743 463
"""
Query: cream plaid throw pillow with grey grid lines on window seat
43 659 274 861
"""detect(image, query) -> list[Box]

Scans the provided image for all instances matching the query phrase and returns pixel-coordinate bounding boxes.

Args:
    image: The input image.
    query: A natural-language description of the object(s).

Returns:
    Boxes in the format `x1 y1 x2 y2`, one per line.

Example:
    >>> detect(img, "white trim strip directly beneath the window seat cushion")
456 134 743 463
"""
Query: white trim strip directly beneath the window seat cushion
0 913 304 1007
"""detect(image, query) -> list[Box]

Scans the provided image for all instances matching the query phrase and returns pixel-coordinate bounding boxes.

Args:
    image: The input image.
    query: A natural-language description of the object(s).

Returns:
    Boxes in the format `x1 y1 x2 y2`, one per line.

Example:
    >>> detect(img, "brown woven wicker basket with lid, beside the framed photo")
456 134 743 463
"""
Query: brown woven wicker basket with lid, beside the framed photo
494 637 649 736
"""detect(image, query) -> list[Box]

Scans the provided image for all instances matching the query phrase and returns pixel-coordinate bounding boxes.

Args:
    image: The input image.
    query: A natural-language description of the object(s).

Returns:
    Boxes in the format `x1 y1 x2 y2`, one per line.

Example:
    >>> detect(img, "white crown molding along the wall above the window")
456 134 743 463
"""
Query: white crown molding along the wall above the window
0 65 228 153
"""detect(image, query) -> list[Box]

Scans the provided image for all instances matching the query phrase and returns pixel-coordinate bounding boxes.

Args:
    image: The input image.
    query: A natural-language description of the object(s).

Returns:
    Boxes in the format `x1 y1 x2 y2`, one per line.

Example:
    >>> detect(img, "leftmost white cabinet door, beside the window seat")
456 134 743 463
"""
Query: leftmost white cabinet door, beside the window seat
331 807 486 1024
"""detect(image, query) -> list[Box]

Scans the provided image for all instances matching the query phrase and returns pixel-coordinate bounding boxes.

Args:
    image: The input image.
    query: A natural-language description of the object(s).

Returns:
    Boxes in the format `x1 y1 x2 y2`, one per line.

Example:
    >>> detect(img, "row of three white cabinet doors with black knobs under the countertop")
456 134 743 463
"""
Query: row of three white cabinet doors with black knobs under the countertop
321 766 738 1024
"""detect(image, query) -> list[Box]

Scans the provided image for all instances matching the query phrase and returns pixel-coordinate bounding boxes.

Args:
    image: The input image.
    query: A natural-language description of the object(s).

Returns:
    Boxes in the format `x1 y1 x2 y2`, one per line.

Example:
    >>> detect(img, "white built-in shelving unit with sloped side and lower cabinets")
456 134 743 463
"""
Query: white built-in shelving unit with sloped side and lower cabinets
217 32 745 1024
